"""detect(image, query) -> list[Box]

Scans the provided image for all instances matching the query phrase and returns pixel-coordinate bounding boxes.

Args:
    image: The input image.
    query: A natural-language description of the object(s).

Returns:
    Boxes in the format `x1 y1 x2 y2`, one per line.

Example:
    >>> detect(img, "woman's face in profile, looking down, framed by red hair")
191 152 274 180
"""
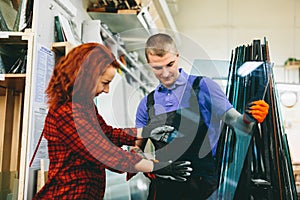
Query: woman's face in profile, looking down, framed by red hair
95 66 117 96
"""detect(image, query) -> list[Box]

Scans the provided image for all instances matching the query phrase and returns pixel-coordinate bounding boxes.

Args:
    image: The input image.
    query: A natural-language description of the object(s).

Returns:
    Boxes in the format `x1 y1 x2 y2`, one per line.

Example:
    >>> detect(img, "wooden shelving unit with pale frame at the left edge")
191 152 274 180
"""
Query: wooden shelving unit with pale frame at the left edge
0 29 33 199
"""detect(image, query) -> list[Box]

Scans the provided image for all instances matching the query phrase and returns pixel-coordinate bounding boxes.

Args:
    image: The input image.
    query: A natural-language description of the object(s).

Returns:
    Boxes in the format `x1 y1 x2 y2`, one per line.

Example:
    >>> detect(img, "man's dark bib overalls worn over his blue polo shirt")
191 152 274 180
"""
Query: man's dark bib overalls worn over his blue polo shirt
147 77 218 200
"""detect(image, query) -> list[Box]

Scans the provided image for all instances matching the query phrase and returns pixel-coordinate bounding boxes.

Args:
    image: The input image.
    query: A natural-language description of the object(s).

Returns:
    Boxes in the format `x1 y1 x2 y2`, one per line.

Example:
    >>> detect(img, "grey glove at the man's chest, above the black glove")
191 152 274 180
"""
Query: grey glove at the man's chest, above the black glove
142 125 174 143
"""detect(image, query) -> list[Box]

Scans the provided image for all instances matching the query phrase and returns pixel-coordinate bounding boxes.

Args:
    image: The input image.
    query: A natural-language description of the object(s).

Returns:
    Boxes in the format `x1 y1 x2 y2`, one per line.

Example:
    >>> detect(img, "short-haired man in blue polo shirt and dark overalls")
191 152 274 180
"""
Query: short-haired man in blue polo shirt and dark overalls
136 33 269 200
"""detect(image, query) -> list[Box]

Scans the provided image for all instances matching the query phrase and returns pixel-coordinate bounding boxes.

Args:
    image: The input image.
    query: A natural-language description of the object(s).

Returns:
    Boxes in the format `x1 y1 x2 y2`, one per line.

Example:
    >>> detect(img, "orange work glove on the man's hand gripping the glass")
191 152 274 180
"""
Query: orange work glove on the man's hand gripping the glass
244 100 269 124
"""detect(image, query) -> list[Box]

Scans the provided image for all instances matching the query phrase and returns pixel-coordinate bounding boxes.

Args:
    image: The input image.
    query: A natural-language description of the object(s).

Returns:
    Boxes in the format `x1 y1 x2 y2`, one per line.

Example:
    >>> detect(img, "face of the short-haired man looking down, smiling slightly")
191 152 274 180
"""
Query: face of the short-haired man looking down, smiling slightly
148 53 179 88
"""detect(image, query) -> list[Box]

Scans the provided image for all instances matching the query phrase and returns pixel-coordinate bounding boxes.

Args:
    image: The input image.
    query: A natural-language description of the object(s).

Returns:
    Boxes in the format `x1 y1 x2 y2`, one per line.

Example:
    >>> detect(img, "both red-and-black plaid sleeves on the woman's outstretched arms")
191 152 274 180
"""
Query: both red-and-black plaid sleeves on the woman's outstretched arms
56 105 141 172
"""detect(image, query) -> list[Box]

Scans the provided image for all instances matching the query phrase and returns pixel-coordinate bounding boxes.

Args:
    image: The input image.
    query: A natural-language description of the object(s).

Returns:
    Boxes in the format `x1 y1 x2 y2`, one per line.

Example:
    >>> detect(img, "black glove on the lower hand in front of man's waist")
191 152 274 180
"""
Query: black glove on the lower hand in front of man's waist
153 160 193 182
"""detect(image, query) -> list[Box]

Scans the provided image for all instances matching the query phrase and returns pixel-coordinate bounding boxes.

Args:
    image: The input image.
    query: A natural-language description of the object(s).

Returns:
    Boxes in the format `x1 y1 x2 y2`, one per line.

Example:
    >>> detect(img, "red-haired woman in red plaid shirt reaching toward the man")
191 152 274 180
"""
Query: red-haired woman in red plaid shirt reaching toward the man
34 43 192 199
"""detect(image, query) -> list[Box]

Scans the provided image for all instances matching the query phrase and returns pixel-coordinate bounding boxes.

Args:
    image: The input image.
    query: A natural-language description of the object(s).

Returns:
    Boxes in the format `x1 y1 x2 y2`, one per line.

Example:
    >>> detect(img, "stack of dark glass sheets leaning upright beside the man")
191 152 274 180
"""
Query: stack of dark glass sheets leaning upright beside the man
211 39 297 200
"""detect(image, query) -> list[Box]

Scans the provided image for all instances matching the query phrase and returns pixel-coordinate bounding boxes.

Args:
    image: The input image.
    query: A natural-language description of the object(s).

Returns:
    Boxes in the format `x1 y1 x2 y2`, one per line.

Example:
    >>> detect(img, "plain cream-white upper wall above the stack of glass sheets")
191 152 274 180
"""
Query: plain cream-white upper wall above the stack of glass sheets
173 0 300 65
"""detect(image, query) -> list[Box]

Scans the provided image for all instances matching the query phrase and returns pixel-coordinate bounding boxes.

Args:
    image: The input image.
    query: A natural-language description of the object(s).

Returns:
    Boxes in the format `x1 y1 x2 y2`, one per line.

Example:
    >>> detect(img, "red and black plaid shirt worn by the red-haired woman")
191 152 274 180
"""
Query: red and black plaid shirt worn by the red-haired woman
34 103 141 200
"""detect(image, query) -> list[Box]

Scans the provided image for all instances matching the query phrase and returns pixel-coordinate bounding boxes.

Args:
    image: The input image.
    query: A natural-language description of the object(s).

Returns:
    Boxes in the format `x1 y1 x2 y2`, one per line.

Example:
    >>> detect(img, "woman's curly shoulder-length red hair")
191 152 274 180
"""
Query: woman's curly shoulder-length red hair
46 43 120 108
